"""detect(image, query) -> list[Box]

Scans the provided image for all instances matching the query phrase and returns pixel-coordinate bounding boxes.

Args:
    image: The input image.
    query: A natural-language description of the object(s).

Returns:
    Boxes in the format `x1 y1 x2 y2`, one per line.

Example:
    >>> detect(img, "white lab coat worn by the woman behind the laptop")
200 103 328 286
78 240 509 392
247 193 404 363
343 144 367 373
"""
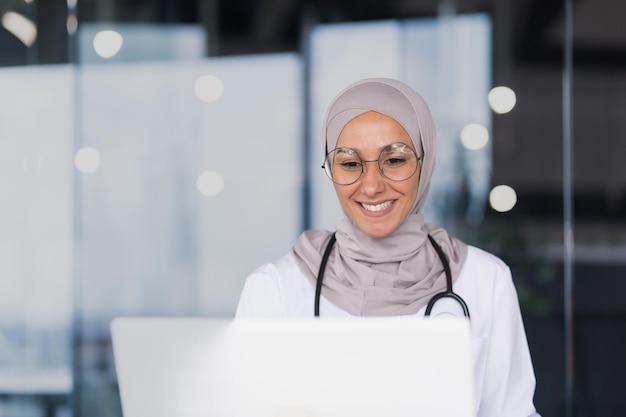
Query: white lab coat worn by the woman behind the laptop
236 246 539 417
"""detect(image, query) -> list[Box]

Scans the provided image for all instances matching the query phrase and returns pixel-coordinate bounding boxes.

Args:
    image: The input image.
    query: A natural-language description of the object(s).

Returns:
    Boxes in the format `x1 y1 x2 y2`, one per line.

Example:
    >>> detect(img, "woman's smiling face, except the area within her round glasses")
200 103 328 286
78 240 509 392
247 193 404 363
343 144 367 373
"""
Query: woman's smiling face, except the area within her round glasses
335 111 421 238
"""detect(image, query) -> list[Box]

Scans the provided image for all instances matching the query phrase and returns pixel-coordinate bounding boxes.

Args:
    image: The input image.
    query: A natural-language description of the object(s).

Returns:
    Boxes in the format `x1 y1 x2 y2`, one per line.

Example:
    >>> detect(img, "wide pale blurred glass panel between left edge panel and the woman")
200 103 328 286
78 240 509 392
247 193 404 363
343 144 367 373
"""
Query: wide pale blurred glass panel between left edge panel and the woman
74 37 302 416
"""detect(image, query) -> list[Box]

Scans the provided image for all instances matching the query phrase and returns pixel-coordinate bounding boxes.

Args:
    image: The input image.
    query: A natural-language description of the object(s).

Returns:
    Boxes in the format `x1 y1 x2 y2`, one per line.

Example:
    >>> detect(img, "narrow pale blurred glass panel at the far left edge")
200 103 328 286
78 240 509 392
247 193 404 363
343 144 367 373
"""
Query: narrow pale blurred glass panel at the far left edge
0 65 74 415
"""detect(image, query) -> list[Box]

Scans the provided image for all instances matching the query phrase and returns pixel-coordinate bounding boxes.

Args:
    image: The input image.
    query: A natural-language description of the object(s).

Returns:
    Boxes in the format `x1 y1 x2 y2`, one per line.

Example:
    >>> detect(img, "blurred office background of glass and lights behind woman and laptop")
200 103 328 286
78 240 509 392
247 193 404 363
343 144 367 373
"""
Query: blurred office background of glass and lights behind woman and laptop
0 0 626 417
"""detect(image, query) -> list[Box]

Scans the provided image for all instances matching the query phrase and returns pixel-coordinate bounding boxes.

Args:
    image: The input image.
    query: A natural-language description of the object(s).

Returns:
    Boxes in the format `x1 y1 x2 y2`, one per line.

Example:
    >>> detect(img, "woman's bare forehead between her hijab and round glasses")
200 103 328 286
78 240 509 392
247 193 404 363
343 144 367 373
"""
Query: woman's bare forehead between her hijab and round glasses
337 111 415 151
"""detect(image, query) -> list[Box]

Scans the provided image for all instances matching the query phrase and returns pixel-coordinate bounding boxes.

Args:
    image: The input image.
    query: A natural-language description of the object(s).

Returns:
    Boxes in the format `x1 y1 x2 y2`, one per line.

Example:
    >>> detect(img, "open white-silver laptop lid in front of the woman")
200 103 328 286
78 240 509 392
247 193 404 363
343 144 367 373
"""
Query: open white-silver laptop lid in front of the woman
111 318 474 417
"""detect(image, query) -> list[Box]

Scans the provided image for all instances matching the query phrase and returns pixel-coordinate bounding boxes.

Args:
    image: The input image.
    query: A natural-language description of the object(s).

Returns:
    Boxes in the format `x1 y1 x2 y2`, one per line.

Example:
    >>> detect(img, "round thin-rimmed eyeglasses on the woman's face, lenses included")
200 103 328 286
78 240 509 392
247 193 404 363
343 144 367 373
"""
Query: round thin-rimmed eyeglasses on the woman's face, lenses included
322 142 421 185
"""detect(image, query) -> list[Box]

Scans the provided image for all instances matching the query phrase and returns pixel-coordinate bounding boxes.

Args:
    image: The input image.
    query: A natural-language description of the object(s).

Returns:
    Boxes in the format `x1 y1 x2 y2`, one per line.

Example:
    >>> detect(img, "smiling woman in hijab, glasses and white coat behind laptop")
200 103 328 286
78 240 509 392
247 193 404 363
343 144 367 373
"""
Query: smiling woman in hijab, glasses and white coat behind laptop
237 78 537 417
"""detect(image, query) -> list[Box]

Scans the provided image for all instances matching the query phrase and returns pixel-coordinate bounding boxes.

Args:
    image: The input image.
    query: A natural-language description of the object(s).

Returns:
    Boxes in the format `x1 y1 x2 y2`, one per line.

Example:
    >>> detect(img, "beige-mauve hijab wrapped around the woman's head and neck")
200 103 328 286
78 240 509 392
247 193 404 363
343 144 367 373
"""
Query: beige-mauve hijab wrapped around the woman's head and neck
293 78 467 316
